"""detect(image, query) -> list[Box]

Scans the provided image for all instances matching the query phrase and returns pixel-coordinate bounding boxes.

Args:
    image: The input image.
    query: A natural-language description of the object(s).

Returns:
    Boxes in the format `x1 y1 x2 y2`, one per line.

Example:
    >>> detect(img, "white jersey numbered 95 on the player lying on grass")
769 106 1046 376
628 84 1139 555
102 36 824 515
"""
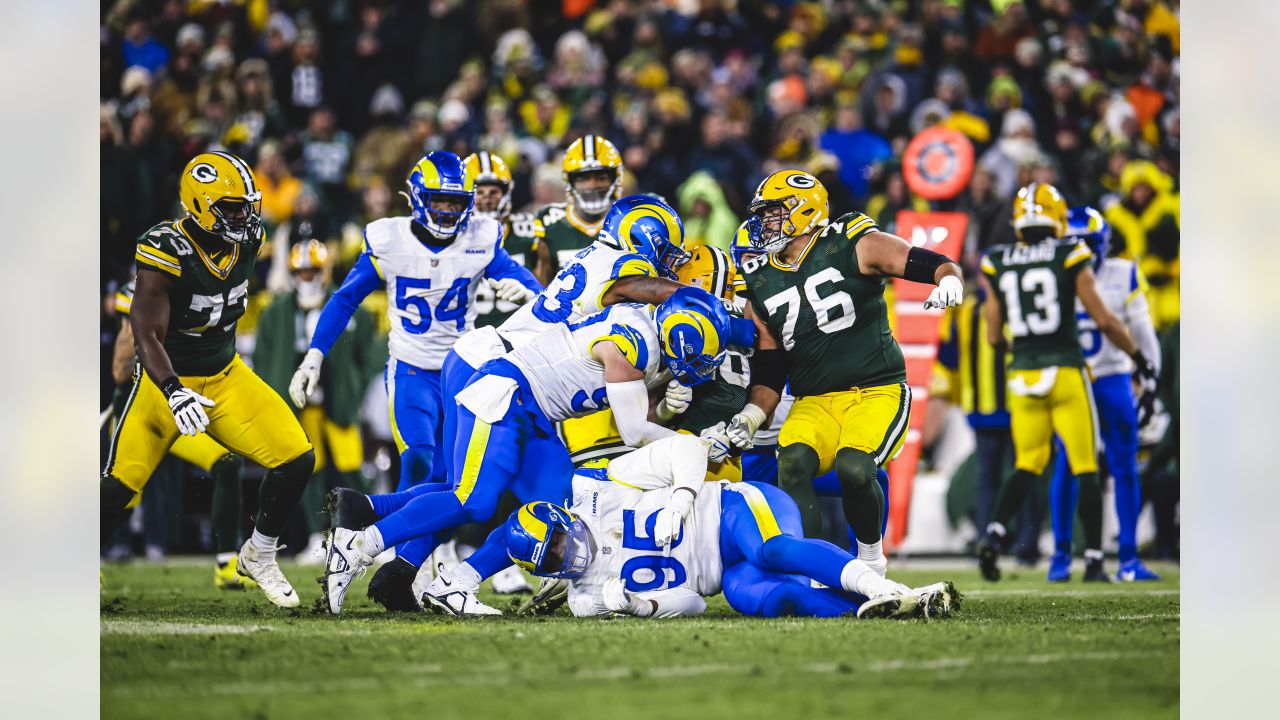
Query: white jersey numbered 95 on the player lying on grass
568 438 730 616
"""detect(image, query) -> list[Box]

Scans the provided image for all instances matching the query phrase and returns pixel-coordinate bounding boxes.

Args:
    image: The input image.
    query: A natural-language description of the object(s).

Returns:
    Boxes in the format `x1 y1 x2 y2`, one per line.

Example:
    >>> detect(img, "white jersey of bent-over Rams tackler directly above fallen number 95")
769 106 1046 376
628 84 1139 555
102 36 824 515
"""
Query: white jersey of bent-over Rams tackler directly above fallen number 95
506 302 671 423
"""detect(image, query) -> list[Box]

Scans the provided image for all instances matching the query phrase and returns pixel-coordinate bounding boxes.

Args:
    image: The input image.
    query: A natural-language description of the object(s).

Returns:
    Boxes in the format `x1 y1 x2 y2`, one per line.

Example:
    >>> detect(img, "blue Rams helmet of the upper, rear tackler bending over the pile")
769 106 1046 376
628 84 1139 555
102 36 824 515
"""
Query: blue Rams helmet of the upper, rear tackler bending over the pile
599 195 689 279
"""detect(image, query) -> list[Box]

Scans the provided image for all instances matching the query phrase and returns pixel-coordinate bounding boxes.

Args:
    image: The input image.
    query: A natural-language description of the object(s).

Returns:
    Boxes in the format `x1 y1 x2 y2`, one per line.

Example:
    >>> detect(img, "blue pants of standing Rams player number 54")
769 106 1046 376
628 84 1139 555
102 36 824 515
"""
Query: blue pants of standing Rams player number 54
383 357 445 491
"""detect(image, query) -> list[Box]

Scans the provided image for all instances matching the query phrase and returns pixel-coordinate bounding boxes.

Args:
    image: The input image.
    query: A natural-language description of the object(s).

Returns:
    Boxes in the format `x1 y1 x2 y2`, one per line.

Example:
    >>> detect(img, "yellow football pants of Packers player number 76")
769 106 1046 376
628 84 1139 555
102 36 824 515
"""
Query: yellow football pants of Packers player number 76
778 383 911 475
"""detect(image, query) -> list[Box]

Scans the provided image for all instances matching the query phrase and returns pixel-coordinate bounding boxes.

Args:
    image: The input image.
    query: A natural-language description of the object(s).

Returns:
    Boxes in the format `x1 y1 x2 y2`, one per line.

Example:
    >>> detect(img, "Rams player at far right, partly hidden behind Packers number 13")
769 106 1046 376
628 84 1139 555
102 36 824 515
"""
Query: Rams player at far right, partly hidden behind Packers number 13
1048 208 1160 582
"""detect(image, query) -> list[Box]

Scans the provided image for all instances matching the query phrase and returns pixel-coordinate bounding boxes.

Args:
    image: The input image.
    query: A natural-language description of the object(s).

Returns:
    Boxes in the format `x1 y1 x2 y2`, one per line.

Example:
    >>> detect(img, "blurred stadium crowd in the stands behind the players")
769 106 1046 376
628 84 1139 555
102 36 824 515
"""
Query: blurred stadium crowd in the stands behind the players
100 0 1180 553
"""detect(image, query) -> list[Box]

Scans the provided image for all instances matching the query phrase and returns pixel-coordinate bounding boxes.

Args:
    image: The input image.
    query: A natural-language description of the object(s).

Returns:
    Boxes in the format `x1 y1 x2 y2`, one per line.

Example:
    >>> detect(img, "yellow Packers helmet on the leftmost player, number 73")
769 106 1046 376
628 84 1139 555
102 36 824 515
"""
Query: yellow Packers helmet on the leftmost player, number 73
178 152 262 243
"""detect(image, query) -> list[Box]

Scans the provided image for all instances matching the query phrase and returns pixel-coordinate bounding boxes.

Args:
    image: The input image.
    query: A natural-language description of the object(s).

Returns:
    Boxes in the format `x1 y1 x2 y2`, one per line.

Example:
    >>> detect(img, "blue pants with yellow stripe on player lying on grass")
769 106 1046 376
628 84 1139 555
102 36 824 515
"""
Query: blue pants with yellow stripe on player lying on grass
708 483 861 618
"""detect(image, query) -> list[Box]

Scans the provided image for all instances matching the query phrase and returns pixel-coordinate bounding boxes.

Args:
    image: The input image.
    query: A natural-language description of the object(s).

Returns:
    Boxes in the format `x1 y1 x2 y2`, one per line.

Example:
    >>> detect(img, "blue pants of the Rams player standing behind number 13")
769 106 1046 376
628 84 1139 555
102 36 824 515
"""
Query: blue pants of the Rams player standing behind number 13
1050 374 1142 562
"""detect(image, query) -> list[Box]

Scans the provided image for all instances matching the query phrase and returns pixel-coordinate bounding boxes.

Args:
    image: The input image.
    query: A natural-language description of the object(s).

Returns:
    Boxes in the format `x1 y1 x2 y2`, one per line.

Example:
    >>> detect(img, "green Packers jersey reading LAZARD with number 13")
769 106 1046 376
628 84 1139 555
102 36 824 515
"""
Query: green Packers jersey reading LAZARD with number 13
982 238 1093 370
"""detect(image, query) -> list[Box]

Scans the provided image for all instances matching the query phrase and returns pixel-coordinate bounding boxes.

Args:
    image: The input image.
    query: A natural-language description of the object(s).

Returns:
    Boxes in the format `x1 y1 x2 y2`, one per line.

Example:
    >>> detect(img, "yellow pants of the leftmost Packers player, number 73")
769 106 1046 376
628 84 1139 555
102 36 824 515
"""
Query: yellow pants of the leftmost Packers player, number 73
104 355 311 492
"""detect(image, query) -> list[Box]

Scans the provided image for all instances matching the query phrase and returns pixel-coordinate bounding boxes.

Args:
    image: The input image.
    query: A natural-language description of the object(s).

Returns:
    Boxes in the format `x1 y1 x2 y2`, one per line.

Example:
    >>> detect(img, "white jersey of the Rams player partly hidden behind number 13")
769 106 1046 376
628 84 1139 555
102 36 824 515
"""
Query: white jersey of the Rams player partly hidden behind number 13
1075 258 1160 378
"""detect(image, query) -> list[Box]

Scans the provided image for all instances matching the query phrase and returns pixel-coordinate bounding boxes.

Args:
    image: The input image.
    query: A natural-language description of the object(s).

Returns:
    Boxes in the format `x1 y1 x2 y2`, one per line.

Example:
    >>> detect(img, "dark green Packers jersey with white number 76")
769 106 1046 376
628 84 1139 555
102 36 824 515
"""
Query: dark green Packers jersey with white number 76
742 213 906 397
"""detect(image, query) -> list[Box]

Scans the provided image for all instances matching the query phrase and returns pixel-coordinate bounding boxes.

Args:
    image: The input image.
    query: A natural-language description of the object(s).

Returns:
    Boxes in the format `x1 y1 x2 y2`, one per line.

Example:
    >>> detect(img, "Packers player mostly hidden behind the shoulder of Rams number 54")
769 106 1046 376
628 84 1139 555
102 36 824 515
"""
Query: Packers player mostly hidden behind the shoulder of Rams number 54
462 150 550 328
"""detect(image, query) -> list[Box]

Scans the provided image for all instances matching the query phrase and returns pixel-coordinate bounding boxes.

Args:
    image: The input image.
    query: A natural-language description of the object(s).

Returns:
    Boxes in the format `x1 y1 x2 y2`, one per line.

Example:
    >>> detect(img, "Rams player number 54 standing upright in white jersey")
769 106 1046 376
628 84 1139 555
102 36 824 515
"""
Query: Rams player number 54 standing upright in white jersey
289 151 541 502
